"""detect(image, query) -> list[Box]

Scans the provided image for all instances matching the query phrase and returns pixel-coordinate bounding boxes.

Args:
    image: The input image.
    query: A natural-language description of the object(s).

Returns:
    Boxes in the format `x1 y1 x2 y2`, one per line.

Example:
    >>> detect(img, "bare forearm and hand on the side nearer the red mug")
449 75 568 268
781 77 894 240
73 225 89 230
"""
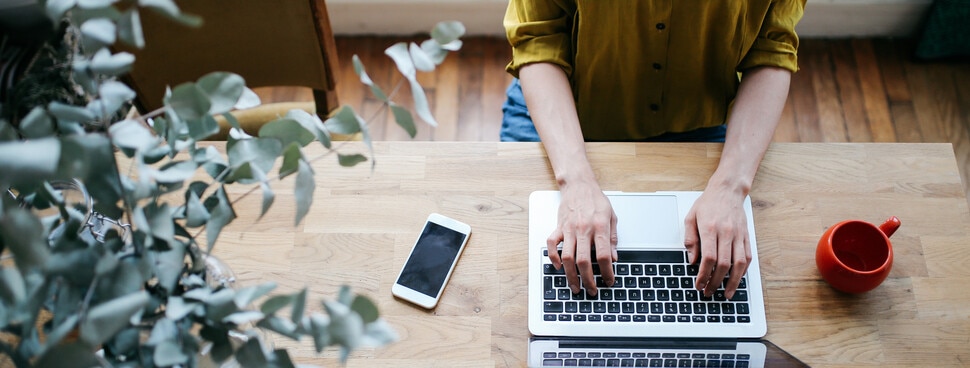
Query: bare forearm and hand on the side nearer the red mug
684 67 791 298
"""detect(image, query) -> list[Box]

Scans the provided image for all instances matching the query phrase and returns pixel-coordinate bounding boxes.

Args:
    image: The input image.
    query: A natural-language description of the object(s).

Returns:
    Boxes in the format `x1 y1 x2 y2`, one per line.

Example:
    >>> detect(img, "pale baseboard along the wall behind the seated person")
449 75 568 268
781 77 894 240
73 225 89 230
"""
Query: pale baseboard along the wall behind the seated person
327 0 932 38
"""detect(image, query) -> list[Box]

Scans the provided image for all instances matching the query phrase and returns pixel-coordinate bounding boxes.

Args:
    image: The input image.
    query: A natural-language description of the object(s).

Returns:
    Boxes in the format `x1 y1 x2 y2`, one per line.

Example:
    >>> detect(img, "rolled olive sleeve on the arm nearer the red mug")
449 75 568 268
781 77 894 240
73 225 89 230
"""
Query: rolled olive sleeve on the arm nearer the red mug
738 0 806 72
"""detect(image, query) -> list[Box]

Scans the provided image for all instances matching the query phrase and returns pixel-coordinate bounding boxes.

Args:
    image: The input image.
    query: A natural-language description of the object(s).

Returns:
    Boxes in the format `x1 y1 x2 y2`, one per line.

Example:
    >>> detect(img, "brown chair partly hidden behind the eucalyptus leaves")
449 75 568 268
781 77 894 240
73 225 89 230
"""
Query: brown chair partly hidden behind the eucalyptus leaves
126 0 338 139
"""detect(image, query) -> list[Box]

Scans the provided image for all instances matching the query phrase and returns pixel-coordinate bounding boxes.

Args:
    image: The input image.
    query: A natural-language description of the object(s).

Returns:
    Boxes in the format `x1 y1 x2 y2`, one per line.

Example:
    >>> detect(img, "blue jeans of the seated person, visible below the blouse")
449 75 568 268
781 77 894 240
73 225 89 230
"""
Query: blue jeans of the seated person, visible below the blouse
499 78 727 142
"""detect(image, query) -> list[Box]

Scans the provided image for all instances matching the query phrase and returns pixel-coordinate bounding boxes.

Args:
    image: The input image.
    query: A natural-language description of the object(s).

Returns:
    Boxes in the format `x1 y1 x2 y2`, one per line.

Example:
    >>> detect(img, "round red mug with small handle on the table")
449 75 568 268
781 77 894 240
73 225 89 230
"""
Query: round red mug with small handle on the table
815 216 900 293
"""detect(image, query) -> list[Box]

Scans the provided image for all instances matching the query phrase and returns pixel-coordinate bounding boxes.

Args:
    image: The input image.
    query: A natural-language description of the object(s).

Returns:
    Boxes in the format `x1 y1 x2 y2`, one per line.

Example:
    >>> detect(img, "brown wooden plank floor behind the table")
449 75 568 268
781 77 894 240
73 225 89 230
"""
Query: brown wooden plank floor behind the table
257 37 970 207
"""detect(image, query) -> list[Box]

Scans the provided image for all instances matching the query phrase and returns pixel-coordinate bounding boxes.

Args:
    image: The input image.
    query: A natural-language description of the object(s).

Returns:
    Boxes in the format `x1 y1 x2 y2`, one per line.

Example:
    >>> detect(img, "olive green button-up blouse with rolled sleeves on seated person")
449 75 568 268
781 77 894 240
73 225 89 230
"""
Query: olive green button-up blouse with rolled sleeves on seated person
505 0 805 140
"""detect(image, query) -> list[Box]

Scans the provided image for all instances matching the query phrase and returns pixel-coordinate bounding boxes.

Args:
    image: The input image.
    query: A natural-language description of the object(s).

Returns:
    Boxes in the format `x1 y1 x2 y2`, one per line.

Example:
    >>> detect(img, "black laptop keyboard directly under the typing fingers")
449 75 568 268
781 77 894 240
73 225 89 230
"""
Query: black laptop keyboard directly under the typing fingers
542 250 751 323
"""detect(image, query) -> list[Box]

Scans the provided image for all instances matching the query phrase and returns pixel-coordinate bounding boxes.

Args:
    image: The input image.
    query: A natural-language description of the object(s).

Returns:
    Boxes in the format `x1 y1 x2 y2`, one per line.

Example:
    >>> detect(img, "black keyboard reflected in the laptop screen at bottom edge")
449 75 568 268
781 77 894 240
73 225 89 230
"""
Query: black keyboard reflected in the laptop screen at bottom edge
542 351 751 368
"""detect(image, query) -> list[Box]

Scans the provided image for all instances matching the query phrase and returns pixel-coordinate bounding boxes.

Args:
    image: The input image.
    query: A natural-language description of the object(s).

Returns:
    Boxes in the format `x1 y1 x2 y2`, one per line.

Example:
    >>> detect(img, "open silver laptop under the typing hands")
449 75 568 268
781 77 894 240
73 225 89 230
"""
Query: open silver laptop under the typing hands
529 191 804 367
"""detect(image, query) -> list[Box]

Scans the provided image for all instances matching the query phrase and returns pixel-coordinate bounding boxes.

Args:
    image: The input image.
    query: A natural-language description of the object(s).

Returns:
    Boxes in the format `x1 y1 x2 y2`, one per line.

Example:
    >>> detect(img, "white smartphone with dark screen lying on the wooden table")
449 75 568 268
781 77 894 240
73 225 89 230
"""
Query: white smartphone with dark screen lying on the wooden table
391 213 472 309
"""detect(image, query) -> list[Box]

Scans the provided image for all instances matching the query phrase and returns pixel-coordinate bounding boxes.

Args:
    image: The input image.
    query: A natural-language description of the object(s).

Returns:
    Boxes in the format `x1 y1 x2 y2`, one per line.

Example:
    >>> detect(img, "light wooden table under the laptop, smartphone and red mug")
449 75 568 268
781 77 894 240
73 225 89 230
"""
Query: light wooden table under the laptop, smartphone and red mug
215 142 970 367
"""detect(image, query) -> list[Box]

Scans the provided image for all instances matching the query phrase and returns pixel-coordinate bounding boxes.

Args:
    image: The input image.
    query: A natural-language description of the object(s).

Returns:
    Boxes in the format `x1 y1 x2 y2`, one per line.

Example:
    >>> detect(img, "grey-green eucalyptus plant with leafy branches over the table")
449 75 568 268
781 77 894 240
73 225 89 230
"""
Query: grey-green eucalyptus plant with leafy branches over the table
0 0 464 367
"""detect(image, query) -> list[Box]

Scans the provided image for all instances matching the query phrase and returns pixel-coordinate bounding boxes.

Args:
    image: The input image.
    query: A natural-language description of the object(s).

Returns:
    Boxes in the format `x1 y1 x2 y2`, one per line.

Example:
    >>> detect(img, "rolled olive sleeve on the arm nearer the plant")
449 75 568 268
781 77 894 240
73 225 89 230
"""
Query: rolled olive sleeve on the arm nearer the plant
504 0 575 78
